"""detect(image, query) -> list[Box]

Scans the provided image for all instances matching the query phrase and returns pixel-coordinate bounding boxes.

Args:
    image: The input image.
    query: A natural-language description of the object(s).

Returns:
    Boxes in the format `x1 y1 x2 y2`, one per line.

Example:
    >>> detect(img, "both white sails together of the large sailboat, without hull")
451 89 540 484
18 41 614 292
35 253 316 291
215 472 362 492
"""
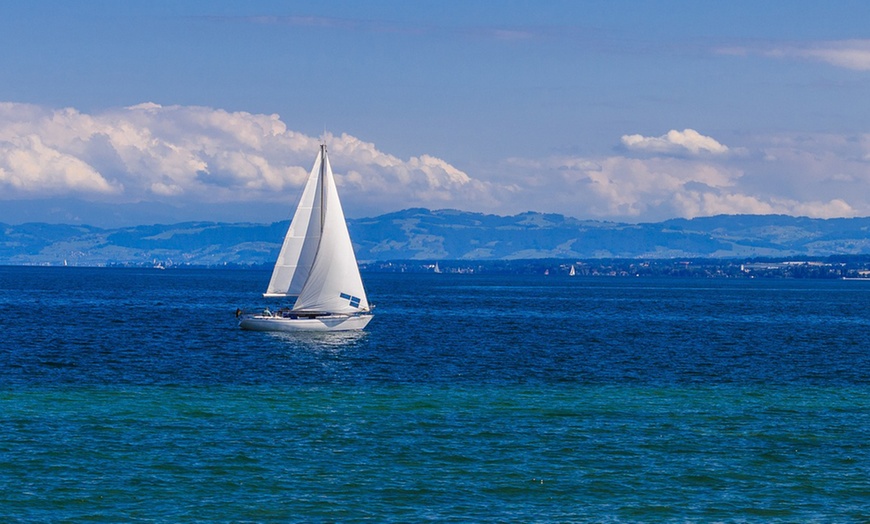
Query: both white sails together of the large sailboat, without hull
265 145 369 313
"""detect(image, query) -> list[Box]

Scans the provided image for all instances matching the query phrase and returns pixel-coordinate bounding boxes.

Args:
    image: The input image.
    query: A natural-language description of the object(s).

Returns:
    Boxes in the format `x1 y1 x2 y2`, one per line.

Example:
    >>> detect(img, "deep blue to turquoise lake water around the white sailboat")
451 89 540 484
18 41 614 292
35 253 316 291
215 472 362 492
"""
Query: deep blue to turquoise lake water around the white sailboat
0 267 870 522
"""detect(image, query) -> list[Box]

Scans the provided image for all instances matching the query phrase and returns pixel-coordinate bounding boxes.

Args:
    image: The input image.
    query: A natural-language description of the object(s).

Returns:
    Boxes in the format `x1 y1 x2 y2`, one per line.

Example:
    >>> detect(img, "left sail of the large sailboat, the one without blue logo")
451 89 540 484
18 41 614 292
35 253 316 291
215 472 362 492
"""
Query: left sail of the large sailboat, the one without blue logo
264 154 322 297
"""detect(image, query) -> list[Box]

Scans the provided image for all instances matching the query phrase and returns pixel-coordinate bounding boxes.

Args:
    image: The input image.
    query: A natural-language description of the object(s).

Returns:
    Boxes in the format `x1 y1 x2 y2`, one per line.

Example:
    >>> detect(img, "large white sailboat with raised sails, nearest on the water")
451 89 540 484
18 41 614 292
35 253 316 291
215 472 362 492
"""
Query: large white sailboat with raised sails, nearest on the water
237 144 372 331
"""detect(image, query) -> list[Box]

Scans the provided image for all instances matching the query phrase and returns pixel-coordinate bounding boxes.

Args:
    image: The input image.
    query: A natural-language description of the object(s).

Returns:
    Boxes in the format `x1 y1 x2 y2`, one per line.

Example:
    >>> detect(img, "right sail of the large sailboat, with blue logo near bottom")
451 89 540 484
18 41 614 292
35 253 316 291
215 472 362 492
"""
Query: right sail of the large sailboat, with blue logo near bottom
293 146 369 313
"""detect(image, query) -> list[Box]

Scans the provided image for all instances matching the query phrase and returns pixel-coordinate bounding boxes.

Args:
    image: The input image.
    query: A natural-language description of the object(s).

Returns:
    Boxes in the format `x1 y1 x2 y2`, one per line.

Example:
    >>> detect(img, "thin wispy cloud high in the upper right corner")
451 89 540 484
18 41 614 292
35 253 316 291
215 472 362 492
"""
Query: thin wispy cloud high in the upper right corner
719 39 870 71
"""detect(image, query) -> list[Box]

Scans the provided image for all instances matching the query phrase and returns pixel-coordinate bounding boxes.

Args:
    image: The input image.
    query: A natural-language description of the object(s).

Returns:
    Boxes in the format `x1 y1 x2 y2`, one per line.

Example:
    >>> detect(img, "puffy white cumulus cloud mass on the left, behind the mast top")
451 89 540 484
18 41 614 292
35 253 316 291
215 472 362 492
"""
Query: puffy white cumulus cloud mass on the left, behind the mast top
0 103 498 214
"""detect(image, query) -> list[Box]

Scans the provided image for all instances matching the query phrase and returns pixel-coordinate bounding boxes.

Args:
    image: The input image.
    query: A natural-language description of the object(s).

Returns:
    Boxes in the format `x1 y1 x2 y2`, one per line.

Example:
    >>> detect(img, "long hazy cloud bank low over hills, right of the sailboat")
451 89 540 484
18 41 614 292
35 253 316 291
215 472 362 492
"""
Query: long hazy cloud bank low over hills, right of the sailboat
490 133 870 221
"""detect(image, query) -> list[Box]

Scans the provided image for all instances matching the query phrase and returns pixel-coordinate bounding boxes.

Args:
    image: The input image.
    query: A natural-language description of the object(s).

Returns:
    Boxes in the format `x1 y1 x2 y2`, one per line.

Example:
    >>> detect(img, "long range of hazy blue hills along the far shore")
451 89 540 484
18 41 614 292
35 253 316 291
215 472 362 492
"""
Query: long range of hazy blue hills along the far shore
0 209 870 266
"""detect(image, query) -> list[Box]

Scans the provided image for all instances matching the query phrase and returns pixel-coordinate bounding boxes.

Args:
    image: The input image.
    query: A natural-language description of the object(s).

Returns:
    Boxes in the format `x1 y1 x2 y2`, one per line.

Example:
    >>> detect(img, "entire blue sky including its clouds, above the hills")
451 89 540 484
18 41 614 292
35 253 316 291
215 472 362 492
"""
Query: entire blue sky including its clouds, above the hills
0 0 870 225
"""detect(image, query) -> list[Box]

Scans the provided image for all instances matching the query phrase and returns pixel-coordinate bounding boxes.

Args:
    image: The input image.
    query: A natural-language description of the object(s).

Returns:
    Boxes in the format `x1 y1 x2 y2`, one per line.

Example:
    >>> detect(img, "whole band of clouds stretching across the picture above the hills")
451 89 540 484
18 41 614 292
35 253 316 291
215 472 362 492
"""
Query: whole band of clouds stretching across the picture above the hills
0 103 870 222
